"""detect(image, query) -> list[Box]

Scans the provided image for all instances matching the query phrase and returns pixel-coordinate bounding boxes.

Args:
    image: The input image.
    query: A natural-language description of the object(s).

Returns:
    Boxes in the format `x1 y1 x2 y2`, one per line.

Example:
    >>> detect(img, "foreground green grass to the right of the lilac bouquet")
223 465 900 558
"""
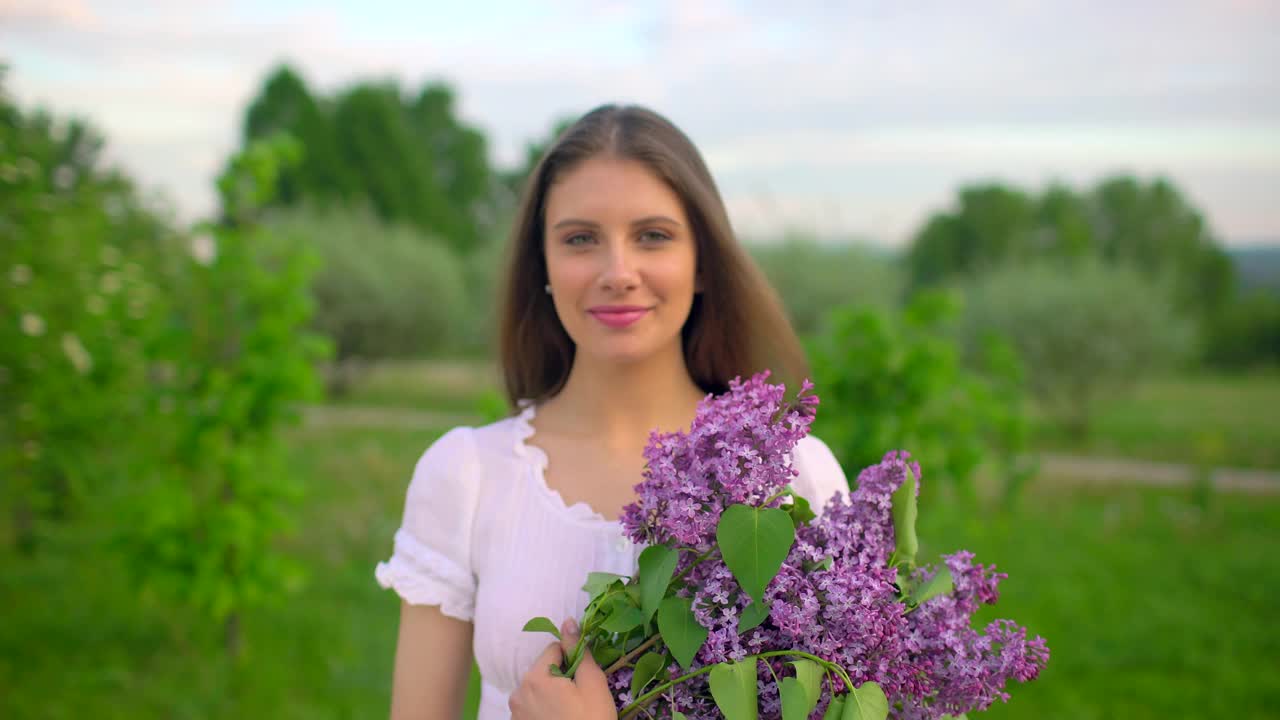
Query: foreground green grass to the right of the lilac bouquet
920 479 1280 719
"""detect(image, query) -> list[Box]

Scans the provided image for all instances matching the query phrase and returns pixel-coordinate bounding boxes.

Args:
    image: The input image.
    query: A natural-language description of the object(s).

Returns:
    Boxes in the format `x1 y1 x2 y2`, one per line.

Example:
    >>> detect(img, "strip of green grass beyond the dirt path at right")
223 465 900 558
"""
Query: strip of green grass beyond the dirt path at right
1037 372 1280 469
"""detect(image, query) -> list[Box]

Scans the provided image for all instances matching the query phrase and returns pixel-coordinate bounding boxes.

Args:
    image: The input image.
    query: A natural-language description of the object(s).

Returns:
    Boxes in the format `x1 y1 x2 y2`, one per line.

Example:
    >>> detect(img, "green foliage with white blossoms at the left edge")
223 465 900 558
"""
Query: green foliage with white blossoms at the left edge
0 70 178 551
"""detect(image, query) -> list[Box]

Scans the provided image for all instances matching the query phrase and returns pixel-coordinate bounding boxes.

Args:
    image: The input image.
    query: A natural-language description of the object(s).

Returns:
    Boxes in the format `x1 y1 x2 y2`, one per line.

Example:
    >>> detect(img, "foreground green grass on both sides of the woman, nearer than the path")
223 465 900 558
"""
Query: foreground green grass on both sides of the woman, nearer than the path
0 407 1280 720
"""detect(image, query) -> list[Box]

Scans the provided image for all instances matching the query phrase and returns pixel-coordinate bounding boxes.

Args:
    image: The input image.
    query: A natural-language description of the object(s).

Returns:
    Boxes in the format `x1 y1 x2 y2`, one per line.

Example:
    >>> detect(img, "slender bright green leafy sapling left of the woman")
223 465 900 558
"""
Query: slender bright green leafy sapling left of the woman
118 137 326 655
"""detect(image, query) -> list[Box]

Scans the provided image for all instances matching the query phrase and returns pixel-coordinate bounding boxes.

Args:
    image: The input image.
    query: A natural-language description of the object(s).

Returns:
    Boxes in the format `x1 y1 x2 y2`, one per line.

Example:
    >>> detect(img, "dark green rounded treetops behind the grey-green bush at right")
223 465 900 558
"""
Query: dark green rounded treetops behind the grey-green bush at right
908 177 1234 319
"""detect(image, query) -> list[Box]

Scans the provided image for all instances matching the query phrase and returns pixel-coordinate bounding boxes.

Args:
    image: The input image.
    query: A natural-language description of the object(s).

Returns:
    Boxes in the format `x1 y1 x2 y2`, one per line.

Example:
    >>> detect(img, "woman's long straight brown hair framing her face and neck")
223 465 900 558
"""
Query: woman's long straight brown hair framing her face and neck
499 105 808 407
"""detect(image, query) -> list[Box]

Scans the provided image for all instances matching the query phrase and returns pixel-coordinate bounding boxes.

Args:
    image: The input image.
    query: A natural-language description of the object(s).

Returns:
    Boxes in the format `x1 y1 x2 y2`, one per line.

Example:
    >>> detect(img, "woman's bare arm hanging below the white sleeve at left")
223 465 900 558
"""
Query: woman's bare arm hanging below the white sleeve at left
392 602 472 720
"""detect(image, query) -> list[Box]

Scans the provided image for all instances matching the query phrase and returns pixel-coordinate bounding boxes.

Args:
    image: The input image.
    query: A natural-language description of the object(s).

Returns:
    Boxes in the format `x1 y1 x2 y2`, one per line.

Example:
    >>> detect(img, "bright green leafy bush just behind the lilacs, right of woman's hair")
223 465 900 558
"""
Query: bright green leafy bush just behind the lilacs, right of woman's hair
809 288 1034 498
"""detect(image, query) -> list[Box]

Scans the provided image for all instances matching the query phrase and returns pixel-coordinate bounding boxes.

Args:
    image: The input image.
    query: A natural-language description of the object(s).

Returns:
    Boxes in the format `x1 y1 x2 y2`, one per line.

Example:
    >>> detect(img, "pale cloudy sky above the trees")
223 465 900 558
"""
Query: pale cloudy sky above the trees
0 0 1280 246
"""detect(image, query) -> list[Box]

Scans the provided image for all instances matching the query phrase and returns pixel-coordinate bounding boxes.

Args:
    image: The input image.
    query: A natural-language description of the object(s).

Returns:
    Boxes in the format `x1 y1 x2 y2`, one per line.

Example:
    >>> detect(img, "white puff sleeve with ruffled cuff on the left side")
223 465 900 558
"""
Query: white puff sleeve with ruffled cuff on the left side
374 428 480 620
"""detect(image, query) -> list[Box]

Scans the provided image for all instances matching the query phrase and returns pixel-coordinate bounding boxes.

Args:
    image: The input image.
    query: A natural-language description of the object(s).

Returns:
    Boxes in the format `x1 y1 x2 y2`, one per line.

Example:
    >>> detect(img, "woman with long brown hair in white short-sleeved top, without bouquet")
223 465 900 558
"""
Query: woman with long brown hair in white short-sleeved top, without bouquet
378 105 846 720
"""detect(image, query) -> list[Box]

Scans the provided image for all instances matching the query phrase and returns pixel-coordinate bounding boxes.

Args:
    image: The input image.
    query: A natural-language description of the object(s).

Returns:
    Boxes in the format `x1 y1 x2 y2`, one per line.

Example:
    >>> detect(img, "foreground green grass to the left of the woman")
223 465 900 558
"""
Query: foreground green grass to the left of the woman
0 420 450 720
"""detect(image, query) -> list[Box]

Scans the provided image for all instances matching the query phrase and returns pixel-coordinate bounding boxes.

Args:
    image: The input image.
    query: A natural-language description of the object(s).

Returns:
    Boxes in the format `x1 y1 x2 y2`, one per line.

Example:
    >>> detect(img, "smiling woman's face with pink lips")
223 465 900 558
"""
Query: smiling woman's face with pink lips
543 155 700 363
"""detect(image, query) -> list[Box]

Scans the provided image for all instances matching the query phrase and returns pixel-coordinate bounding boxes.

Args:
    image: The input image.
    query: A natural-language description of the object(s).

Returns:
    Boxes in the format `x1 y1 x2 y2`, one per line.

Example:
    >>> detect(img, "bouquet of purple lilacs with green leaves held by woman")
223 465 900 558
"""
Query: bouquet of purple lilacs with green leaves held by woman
525 372 1048 720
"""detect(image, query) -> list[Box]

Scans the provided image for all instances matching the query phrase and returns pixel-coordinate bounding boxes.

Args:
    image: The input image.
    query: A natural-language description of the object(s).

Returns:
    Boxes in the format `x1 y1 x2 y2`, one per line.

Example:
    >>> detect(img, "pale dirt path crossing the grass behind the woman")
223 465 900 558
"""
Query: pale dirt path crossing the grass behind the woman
303 405 1280 495
